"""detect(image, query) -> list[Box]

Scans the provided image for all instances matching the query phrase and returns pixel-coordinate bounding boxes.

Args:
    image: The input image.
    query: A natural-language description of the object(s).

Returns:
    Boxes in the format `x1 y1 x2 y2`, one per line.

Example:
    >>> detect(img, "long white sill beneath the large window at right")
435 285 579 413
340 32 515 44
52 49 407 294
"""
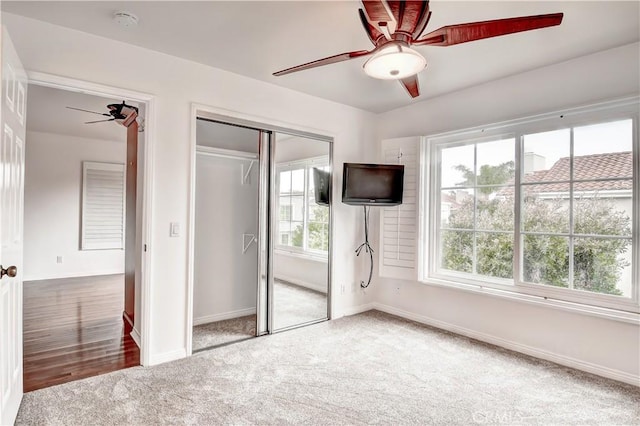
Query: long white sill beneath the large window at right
419 278 640 325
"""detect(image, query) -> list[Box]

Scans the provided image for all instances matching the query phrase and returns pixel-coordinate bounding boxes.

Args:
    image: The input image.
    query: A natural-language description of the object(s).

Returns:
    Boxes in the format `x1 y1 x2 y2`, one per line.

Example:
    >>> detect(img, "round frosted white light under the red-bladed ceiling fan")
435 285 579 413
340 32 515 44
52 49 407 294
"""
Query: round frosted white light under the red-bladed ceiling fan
363 43 427 80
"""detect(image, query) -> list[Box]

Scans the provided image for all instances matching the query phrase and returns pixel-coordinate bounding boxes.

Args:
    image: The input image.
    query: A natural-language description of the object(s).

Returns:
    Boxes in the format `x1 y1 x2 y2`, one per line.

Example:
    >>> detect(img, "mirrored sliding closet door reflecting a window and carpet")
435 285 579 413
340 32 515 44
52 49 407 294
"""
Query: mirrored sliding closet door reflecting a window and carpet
270 133 331 331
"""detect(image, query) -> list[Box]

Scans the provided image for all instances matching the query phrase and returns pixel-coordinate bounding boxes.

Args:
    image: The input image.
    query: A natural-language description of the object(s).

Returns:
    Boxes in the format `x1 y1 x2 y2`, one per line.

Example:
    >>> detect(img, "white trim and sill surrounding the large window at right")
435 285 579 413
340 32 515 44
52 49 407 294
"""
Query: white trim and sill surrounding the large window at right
418 97 640 314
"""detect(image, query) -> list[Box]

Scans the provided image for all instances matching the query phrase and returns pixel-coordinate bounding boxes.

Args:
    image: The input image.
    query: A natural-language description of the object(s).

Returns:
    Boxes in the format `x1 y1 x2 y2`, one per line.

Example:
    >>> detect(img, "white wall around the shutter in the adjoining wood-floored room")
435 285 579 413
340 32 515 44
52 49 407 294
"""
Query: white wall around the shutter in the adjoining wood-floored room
24 131 126 281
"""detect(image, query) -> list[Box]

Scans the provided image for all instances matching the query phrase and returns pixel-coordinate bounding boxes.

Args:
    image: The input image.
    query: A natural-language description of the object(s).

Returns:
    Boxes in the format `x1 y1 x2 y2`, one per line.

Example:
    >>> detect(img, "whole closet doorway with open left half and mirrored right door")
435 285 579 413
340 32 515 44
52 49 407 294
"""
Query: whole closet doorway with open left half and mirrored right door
187 105 332 354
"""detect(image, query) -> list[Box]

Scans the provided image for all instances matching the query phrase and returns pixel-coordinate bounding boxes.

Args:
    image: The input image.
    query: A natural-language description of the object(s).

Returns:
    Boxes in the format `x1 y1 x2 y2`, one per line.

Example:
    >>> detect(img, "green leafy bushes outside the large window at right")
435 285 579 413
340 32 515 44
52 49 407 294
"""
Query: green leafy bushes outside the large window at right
441 197 631 295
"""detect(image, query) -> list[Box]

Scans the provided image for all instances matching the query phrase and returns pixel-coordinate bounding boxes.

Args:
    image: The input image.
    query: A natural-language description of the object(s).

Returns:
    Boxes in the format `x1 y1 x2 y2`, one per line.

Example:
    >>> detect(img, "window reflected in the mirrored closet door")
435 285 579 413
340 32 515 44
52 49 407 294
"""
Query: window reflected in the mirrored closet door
276 157 329 255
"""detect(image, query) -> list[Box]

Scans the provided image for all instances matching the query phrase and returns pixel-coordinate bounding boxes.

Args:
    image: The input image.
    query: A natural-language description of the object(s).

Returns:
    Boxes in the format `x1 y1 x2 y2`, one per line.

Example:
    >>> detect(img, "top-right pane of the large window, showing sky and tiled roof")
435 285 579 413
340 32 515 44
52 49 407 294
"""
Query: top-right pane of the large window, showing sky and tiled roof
573 120 633 180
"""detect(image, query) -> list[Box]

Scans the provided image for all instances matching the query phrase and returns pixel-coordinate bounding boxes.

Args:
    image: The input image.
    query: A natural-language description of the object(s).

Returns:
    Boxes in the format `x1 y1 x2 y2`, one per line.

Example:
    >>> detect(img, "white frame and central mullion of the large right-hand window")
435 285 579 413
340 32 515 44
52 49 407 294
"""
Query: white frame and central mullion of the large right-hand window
418 97 640 313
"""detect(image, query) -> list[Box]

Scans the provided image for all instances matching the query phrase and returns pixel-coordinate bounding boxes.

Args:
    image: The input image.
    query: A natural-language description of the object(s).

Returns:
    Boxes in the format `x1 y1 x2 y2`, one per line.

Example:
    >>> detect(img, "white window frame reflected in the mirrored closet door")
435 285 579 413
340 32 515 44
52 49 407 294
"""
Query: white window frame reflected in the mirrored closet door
275 155 331 261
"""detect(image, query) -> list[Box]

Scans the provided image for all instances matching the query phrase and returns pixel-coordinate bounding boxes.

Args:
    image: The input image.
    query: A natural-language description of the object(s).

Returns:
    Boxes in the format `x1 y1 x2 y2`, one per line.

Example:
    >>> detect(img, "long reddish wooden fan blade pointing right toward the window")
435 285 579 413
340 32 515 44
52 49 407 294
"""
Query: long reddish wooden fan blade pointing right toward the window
412 13 563 46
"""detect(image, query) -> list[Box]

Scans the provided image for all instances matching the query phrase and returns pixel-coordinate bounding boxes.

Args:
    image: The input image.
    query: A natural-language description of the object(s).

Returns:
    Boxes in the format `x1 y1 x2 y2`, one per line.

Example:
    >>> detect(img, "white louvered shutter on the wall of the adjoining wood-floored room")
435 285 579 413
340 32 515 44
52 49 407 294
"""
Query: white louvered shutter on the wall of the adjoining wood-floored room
80 161 125 250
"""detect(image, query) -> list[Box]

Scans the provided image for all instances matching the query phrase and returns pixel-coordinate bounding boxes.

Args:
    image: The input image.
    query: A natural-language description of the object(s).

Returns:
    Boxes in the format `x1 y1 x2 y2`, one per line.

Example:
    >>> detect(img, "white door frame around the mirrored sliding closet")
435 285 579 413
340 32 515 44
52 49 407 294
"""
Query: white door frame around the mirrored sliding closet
185 102 337 356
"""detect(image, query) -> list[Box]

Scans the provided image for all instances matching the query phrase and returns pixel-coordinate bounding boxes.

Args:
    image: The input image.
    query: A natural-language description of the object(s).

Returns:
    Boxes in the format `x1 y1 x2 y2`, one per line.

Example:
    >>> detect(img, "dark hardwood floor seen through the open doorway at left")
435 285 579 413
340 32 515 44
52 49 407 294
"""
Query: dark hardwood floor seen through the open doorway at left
23 275 140 392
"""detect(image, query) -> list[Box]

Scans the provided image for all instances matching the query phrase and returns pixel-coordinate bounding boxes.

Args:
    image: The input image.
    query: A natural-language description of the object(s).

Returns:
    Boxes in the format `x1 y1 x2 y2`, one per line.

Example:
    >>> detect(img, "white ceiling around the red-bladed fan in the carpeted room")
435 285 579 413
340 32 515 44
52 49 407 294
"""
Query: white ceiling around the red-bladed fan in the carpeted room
2 0 640 112
